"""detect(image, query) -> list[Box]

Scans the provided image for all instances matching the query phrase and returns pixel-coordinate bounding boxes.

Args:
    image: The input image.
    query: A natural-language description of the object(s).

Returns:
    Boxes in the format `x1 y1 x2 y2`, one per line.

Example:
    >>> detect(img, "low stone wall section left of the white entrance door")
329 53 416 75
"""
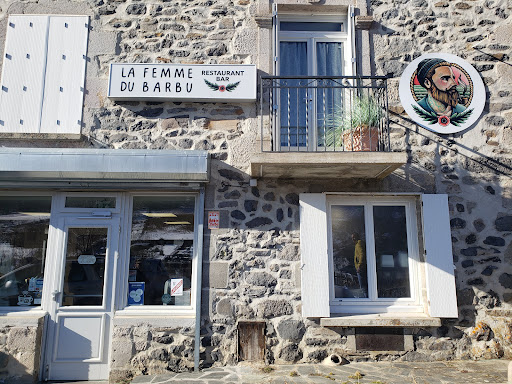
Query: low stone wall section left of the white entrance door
0 316 44 384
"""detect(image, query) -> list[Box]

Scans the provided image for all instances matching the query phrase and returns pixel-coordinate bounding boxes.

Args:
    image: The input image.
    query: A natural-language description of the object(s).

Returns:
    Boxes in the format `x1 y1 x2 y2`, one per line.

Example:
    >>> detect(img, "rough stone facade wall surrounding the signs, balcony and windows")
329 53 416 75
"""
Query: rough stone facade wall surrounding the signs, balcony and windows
0 0 512 379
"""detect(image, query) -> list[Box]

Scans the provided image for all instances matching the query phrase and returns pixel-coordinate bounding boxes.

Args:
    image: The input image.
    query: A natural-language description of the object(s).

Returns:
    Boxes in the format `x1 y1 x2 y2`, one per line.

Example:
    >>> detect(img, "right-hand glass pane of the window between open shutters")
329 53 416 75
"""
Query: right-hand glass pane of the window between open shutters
373 206 411 298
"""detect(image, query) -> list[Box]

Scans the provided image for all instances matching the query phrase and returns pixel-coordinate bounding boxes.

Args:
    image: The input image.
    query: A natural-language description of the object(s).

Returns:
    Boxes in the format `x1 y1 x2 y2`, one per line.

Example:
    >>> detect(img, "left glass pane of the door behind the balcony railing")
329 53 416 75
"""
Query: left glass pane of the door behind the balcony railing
279 41 312 147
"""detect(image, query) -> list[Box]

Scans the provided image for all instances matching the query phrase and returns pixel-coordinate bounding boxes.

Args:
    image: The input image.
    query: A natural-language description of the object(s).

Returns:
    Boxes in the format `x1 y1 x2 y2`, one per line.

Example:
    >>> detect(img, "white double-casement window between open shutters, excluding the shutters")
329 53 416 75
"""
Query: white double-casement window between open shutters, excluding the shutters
327 196 423 313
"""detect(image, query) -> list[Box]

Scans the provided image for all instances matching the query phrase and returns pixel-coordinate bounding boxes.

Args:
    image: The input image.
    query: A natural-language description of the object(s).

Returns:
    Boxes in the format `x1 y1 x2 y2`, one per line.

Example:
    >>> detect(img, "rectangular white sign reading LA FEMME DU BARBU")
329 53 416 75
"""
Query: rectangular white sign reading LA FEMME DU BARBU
108 63 256 102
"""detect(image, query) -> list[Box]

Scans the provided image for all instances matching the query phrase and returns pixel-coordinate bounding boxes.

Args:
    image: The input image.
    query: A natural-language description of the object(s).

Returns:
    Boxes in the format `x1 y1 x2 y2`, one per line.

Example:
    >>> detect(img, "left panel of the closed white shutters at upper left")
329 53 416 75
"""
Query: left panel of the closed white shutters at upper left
0 15 48 133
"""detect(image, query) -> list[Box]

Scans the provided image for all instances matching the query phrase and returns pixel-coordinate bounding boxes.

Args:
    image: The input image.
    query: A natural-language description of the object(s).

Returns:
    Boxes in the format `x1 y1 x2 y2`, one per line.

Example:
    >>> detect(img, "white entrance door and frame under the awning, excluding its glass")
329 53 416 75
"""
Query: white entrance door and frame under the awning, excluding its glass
43 193 121 380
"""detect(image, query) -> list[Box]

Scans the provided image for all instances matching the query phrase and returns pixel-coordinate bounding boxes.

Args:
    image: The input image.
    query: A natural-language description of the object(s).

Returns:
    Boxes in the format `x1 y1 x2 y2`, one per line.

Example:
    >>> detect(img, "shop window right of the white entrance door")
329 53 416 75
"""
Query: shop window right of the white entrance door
118 193 202 315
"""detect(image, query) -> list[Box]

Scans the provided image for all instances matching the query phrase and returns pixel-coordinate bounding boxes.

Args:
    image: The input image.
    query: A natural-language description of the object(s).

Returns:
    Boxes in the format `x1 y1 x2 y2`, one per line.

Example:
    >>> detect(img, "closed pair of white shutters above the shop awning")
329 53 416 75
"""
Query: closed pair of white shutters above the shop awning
0 15 89 135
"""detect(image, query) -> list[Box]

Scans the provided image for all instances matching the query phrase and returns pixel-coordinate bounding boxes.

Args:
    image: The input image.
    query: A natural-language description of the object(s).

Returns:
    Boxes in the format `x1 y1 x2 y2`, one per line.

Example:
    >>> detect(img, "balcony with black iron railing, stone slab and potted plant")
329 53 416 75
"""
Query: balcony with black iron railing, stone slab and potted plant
250 76 407 179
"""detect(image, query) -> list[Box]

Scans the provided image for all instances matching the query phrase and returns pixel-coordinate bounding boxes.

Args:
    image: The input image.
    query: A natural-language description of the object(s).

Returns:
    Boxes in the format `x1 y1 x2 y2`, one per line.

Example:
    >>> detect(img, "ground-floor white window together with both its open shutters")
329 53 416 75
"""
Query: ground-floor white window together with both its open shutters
300 193 457 317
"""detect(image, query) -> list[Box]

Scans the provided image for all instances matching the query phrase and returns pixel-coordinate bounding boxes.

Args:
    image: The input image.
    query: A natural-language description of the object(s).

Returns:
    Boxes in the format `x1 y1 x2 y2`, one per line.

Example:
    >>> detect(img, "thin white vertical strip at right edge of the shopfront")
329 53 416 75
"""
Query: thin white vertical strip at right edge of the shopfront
194 188 204 372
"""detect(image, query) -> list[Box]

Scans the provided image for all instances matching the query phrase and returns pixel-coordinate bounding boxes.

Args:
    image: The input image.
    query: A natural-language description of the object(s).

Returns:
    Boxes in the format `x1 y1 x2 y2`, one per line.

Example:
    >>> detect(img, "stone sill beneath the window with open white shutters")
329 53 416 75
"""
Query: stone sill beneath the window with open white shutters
320 313 441 327
